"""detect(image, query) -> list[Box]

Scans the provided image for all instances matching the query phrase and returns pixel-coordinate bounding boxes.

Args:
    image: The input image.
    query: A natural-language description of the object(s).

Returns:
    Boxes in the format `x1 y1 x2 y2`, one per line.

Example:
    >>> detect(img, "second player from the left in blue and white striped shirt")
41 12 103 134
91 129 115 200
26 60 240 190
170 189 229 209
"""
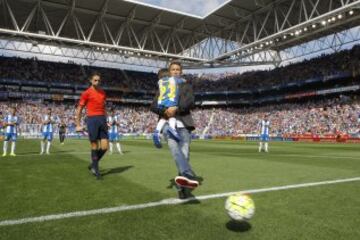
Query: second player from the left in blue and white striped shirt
40 108 56 155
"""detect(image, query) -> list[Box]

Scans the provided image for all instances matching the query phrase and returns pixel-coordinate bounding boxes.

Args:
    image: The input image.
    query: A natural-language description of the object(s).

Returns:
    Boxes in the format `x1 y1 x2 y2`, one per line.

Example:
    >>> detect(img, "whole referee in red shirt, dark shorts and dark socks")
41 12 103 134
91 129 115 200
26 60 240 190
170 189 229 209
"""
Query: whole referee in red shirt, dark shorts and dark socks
76 73 109 180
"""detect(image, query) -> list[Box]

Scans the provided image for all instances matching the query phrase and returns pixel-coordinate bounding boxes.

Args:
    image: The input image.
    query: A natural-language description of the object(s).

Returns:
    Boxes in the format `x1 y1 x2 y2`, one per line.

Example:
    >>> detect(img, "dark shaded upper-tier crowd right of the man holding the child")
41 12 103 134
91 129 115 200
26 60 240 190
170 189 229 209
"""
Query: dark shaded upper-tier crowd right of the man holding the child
187 45 360 91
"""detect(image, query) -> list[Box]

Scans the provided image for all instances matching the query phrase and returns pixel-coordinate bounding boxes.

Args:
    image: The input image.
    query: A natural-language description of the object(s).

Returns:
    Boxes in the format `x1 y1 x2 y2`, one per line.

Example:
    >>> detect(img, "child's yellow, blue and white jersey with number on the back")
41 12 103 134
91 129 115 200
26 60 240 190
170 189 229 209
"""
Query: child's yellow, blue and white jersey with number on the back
158 77 185 108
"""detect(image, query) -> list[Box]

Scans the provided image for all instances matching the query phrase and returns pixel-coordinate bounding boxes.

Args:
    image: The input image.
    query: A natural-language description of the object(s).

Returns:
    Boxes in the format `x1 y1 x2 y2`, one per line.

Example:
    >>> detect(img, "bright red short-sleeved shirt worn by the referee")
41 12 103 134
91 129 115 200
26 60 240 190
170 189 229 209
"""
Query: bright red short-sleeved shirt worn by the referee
79 87 106 117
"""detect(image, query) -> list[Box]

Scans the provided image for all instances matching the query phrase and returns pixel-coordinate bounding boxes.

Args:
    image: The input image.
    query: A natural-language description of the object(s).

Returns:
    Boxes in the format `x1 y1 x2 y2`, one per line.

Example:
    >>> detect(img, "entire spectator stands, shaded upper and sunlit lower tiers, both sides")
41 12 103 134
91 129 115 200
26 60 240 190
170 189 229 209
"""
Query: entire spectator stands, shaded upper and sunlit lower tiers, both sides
0 46 360 139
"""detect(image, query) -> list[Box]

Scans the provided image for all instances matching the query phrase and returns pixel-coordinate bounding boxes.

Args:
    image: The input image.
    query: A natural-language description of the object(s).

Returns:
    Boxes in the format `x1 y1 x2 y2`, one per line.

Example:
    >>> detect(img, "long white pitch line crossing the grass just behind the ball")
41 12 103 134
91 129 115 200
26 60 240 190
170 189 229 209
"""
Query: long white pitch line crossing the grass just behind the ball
0 177 360 226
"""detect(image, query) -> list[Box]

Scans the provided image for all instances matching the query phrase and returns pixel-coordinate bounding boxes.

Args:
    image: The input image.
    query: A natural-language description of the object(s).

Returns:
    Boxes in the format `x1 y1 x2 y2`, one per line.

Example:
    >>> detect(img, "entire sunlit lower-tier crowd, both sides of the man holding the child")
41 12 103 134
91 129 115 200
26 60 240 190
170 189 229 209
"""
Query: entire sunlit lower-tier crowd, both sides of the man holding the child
0 98 360 136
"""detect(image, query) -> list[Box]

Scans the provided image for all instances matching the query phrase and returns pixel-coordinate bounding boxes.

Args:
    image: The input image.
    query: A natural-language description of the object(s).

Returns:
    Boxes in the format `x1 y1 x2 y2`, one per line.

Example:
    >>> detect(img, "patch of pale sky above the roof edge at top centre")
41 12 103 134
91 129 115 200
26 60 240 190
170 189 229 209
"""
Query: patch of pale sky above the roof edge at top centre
127 0 228 18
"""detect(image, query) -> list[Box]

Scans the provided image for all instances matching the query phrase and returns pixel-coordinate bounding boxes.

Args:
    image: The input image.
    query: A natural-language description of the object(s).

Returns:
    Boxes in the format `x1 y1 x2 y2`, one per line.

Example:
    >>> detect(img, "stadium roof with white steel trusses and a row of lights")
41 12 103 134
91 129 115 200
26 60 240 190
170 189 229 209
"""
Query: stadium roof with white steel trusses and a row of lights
0 0 360 66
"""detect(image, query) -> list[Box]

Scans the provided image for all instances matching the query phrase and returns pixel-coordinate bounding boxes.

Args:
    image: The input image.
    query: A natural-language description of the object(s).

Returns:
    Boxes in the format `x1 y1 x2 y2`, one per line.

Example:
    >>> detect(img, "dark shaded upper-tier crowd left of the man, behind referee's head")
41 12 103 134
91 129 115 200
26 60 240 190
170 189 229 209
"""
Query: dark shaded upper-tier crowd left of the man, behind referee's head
0 57 157 91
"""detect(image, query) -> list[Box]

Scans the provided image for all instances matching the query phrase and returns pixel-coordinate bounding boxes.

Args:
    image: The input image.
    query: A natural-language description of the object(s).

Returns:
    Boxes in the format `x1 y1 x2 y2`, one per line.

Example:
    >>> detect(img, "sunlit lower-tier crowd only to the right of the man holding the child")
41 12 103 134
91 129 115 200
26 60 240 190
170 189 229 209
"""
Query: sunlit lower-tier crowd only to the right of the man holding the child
197 96 360 136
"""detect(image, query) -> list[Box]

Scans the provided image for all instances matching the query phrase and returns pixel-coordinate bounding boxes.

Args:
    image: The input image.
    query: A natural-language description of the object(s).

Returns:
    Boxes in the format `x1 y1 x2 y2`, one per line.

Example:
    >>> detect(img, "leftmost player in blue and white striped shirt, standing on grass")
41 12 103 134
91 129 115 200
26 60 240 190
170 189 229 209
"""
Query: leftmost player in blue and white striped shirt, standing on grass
3 107 19 157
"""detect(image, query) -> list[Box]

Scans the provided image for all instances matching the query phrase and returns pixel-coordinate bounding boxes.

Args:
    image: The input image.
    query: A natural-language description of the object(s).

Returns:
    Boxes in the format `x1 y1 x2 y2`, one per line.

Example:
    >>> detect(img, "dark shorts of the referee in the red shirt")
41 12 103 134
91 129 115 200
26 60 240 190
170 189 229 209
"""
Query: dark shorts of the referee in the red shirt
86 116 109 142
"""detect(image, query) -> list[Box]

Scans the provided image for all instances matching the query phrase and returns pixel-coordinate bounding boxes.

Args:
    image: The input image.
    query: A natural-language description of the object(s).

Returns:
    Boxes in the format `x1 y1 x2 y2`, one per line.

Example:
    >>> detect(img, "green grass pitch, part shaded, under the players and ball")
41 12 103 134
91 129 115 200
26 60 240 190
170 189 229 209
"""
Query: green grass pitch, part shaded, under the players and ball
0 140 360 240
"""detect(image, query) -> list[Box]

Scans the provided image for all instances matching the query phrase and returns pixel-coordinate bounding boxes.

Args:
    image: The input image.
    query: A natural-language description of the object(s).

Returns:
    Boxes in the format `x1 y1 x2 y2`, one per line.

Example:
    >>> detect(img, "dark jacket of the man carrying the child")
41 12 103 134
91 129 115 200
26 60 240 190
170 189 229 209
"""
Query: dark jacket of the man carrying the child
150 82 195 131
